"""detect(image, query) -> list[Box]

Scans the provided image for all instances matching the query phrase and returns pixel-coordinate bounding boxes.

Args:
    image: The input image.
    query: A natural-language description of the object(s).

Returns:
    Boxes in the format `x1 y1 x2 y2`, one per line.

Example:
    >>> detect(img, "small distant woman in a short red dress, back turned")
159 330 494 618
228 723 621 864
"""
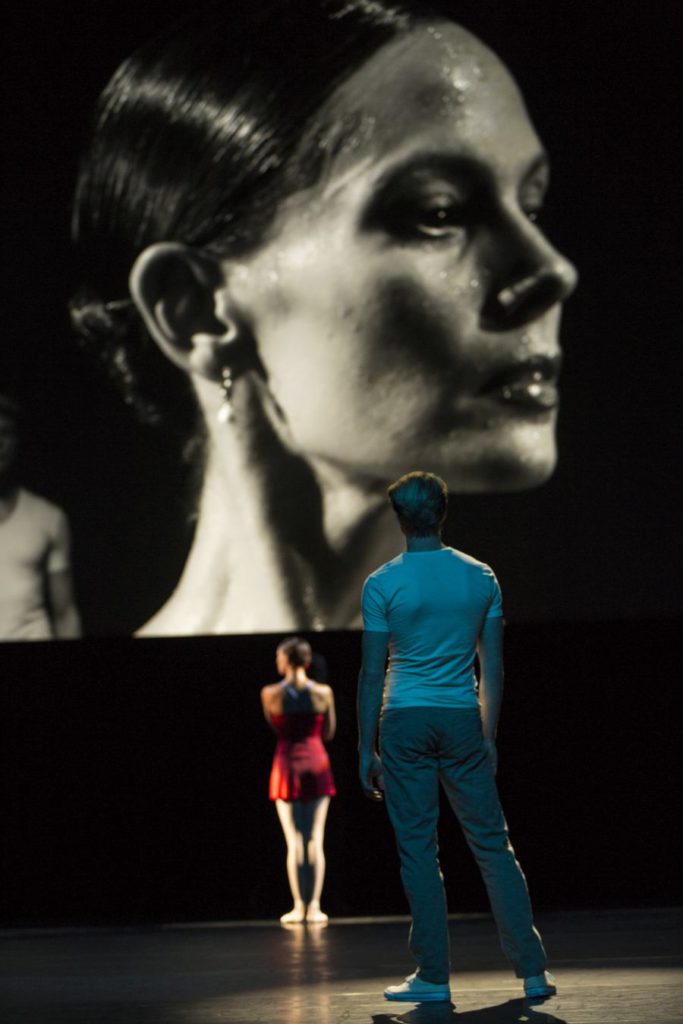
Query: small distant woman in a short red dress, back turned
261 637 336 925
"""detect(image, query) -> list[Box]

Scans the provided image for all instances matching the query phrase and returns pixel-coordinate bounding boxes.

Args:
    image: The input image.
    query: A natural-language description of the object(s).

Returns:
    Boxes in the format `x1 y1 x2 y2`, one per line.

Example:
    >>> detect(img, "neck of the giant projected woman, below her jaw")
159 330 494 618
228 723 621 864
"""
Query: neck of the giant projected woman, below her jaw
139 451 401 636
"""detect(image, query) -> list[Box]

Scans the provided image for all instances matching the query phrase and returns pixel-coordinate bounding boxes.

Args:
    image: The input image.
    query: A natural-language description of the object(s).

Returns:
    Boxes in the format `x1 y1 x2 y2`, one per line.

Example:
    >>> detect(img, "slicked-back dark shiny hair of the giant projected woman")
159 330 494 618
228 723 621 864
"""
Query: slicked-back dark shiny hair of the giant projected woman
71 0 436 429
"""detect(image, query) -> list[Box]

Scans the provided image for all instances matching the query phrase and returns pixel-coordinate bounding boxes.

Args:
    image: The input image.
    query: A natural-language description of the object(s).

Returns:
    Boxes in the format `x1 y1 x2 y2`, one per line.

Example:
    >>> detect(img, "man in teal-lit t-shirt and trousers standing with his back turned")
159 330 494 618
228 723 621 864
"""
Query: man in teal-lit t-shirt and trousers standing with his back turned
357 472 555 1002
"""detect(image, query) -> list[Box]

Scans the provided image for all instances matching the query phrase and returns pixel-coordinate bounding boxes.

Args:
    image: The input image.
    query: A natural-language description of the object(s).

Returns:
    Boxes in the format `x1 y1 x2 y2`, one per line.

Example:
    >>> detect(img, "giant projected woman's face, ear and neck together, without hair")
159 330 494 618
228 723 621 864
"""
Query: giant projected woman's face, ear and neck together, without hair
62 20 575 635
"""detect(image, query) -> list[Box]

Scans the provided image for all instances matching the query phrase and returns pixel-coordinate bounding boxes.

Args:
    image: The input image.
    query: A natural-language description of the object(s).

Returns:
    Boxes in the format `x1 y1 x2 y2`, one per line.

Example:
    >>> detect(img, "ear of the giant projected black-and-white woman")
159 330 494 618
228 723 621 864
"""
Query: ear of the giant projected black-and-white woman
129 242 239 381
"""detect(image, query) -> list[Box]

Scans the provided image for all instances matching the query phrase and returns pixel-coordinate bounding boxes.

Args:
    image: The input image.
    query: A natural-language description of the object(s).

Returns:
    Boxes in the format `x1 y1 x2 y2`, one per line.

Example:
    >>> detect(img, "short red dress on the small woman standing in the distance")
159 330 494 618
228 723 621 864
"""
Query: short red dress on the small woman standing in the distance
269 712 337 800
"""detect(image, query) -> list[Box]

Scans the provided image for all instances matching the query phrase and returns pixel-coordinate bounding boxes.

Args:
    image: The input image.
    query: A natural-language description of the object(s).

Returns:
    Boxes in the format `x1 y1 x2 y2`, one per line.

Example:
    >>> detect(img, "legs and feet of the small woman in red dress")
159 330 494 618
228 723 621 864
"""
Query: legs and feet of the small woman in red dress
275 797 330 925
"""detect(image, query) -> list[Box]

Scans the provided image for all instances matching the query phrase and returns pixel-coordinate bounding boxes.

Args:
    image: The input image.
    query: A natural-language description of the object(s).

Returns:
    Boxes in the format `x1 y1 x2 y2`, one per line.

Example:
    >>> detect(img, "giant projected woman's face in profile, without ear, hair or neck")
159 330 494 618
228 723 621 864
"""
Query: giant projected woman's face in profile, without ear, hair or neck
224 23 575 492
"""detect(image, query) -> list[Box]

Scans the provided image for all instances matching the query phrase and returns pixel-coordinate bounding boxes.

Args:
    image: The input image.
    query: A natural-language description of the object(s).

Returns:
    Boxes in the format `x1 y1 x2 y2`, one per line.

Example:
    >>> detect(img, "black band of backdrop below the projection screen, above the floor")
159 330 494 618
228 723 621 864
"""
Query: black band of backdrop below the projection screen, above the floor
0 622 683 925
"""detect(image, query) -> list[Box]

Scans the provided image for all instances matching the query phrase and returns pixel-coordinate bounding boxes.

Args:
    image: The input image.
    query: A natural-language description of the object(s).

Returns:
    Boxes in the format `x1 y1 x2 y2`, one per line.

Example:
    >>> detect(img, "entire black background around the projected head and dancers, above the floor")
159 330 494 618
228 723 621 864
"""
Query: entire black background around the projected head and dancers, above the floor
0 0 683 924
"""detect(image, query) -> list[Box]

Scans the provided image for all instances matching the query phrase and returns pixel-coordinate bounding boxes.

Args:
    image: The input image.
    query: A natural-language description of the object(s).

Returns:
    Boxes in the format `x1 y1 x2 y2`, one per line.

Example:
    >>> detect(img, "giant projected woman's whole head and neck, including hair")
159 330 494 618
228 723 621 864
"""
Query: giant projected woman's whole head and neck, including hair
65 3 575 635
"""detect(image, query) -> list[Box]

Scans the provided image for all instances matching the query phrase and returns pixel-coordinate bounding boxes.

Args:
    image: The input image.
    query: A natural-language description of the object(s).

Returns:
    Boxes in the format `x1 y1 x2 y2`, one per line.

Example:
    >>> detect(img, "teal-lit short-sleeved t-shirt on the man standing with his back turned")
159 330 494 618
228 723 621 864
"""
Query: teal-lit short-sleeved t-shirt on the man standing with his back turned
362 548 503 709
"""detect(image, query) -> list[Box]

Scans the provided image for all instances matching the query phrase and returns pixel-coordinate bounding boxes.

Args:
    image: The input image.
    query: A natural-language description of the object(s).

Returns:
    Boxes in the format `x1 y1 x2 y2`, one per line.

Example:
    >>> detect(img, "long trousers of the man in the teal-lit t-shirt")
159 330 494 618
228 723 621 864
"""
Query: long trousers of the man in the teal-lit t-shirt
380 708 546 984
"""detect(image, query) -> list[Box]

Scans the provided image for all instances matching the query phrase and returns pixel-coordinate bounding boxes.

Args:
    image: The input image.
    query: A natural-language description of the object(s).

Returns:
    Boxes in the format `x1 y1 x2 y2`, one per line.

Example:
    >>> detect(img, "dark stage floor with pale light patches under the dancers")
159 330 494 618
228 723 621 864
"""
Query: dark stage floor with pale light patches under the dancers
0 908 683 1024
